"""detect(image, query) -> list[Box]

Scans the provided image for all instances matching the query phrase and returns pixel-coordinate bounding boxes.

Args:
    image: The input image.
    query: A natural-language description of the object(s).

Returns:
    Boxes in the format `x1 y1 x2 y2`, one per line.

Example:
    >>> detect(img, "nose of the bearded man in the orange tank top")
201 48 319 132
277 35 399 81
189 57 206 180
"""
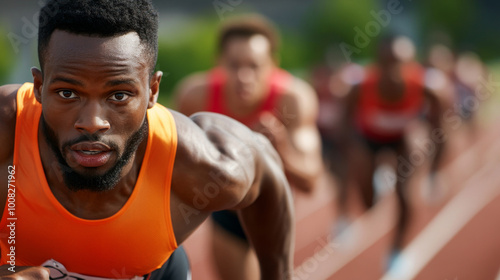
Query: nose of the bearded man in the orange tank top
75 102 110 134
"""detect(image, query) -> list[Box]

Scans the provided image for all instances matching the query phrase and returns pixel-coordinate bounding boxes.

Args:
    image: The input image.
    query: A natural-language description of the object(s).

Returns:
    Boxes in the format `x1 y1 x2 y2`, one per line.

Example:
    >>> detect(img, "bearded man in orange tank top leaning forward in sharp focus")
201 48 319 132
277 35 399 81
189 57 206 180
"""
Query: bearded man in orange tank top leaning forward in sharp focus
0 0 294 280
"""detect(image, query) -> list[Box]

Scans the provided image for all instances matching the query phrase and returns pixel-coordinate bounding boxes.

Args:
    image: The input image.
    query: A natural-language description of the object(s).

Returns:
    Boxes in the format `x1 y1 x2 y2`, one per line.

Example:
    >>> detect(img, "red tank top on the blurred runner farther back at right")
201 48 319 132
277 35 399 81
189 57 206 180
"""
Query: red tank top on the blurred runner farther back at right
356 65 424 142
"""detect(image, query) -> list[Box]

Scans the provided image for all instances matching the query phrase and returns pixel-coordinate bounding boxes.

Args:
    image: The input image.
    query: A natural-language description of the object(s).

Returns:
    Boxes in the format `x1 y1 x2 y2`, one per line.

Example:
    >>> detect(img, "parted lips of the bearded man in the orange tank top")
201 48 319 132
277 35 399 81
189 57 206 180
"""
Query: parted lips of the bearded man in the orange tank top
70 142 112 167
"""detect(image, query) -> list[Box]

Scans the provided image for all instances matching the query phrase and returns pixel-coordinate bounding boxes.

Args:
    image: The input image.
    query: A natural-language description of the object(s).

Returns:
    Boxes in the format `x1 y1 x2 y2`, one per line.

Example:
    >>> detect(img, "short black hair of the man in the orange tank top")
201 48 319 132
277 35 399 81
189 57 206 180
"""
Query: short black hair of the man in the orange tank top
38 0 158 72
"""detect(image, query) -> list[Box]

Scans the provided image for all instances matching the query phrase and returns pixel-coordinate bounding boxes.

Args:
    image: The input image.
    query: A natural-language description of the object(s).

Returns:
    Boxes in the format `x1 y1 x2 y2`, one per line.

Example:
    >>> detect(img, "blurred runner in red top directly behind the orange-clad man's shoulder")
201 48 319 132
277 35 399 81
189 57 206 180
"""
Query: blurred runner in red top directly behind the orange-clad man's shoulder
176 15 323 279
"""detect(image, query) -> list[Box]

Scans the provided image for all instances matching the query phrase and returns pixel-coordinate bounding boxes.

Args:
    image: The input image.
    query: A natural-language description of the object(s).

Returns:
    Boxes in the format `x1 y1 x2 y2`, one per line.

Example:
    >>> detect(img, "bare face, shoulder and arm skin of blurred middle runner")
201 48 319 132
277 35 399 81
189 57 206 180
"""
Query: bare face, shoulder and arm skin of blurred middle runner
176 35 323 192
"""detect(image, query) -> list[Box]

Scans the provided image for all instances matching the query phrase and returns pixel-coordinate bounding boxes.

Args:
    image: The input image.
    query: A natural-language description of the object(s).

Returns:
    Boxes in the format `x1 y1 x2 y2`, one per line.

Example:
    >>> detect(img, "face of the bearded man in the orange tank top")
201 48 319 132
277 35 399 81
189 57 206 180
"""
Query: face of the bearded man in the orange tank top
34 30 161 191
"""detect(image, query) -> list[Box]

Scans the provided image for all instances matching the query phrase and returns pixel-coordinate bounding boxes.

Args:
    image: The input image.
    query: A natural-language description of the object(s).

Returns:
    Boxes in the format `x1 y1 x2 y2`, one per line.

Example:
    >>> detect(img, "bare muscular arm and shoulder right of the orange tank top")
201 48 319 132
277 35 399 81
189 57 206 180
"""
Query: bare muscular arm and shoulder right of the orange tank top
171 110 294 279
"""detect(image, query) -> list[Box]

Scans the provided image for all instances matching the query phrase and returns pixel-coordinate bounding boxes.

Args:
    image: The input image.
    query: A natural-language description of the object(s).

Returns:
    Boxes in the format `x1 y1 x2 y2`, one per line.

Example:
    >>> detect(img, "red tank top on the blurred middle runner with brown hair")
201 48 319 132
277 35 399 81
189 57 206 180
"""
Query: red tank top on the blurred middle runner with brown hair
207 68 291 127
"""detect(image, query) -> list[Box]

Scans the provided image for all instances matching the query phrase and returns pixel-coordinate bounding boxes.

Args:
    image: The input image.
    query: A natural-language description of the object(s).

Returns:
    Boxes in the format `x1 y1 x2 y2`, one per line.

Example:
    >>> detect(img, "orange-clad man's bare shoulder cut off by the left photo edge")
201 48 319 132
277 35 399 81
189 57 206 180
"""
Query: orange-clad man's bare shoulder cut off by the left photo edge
0 85 21 162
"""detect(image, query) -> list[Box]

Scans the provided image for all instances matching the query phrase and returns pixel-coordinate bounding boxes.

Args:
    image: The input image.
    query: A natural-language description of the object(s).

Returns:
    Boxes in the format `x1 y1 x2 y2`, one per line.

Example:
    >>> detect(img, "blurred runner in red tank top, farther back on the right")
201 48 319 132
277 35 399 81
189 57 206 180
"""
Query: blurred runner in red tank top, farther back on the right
340 37 443 264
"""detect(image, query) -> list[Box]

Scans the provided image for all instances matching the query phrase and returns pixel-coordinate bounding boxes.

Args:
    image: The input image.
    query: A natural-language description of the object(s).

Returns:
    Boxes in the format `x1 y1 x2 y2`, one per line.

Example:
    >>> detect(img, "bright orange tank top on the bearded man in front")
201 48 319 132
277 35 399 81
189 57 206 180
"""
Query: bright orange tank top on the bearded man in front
0 83 177 278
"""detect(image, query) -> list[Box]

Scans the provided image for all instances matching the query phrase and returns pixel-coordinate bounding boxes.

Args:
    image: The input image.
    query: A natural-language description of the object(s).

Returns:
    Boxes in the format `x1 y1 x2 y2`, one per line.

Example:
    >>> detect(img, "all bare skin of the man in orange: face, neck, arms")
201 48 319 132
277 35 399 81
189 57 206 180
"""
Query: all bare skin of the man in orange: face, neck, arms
0 30 294 279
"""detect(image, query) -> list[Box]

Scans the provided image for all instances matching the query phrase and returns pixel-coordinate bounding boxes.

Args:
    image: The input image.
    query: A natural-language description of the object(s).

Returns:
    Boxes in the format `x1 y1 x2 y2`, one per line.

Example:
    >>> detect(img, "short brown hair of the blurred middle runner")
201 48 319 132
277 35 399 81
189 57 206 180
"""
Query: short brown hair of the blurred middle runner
218 14 280 55
